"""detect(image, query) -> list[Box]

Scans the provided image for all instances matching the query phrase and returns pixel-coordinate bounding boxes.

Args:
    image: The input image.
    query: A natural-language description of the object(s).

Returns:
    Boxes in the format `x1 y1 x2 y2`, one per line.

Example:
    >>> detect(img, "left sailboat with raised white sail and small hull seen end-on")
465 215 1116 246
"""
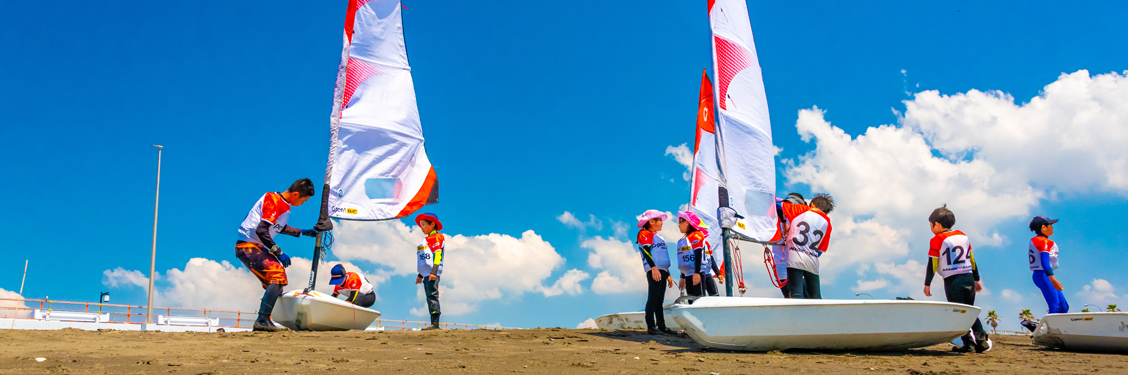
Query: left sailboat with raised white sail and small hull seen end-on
273 0 439 331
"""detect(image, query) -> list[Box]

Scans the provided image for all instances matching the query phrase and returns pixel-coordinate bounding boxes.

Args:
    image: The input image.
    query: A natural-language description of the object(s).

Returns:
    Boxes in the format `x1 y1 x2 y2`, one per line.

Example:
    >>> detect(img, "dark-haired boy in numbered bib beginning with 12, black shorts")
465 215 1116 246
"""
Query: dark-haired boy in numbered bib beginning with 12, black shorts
924 204 992 352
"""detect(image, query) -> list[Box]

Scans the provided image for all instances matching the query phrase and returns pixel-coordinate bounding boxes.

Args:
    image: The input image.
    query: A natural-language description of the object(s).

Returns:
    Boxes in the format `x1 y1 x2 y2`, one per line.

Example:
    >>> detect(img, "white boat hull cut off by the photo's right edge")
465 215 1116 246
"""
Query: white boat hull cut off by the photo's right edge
1034 313 1128 354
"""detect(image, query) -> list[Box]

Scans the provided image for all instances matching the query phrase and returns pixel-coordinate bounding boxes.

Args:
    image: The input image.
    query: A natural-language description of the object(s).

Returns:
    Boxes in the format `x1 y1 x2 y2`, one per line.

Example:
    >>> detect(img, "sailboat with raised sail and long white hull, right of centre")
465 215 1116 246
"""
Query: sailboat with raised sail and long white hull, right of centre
670 0 980 351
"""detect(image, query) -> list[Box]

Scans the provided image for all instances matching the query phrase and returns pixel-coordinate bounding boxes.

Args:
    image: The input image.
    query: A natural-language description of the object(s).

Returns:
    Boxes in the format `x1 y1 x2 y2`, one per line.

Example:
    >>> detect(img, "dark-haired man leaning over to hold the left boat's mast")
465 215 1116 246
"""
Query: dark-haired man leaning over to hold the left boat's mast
235 178 317 332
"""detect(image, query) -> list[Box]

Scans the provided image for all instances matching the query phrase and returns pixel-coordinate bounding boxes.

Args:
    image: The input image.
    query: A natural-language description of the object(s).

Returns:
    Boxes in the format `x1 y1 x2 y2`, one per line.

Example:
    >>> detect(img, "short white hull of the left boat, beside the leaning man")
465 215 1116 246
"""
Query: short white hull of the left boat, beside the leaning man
271 290 380 331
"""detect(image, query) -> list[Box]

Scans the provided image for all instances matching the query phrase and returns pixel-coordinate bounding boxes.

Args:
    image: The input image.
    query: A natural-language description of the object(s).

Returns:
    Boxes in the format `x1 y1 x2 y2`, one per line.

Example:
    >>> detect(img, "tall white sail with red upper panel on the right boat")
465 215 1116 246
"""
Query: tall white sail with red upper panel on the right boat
708 0 776 241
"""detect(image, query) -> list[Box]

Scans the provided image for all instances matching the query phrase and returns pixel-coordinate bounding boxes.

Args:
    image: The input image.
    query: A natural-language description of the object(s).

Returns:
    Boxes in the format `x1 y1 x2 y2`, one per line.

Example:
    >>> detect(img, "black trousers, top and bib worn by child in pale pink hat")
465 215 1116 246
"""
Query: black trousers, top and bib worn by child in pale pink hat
637 229 670 331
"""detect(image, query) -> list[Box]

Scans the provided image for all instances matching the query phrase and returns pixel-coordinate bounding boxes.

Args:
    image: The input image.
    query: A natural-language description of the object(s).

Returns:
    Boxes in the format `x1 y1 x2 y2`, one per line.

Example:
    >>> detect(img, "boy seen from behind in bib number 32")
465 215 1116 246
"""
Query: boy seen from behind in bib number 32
781 194 835 299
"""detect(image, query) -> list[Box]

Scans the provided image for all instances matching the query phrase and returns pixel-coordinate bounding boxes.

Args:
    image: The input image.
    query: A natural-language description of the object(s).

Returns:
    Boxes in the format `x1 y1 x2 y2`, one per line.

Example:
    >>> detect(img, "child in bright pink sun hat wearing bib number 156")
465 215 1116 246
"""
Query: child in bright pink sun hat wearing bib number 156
678 211 710 296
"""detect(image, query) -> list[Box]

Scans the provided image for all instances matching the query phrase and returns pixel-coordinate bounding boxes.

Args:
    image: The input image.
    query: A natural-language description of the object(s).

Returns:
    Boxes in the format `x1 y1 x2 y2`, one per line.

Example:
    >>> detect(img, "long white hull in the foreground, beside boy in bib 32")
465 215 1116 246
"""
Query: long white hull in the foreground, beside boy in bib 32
670 297 980 351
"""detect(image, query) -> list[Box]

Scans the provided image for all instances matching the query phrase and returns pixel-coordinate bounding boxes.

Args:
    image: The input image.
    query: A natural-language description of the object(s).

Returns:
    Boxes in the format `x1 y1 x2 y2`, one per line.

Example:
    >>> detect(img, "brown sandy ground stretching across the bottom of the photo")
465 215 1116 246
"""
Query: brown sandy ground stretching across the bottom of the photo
0 329 1128 375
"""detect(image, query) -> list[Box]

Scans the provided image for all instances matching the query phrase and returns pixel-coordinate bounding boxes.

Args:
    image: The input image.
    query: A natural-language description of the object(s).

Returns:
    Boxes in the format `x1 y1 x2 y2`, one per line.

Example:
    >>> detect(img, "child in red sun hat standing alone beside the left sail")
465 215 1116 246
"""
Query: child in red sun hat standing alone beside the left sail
415 213 446 330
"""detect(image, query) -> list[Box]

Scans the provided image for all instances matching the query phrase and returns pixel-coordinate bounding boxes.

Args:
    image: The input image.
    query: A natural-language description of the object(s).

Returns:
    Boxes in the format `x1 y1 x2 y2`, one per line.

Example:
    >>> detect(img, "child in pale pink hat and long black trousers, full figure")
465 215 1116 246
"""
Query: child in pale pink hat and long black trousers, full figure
637 210 673 334
